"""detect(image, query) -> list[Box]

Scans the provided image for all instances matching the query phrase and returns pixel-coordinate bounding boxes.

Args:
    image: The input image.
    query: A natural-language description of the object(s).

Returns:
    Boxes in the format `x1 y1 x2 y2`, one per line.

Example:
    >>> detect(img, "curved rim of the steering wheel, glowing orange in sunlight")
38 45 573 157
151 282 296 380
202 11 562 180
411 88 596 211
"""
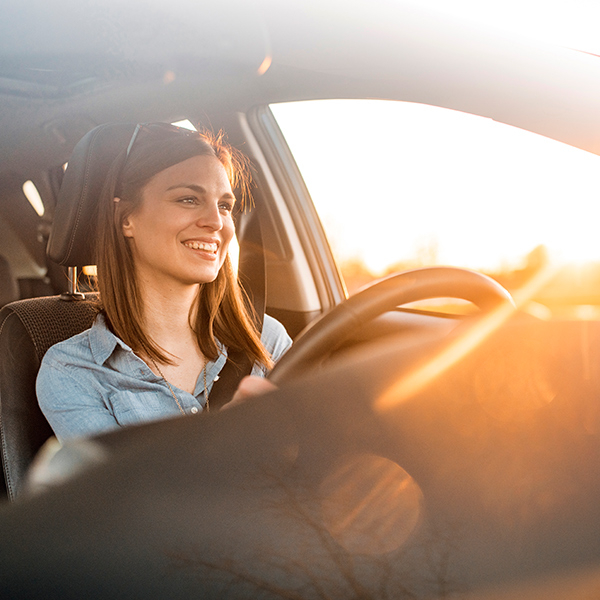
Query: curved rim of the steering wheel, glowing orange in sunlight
269 267 514 384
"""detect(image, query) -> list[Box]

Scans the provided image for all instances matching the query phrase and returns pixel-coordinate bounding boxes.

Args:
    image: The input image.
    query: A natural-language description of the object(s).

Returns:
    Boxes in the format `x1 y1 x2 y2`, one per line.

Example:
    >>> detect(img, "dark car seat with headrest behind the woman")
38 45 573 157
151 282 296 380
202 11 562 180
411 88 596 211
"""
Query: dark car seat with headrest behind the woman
0 123 265 500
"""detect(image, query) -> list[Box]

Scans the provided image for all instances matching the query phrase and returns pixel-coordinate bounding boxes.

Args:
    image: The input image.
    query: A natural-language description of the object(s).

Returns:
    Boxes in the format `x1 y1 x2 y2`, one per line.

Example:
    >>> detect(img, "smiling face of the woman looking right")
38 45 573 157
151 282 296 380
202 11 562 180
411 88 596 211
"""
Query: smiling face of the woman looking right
123 156 235 289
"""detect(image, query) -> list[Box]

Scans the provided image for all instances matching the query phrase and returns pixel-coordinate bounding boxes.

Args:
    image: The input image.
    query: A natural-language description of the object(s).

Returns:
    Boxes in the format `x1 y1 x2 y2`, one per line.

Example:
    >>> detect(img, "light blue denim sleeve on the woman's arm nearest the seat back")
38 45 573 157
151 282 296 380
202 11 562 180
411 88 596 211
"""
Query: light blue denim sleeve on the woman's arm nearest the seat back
36 348 119 442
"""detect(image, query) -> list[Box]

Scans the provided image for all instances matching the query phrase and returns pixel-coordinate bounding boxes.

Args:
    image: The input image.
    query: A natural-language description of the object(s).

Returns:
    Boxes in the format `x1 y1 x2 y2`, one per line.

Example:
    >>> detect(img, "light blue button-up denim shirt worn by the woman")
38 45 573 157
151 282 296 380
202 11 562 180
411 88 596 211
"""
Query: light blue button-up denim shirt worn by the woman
36 314 292 441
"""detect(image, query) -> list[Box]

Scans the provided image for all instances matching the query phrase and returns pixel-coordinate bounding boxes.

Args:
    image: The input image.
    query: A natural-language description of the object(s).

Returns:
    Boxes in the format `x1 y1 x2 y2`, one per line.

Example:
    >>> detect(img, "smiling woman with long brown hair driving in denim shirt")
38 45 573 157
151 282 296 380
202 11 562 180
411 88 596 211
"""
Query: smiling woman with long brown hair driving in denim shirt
37 123 291 440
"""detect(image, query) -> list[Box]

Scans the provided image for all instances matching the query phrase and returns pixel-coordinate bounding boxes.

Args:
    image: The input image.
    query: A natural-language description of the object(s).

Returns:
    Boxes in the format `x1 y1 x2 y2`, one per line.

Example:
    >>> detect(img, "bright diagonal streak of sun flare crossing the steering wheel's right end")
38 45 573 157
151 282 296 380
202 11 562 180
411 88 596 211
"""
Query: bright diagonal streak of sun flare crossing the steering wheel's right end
375 264 555 412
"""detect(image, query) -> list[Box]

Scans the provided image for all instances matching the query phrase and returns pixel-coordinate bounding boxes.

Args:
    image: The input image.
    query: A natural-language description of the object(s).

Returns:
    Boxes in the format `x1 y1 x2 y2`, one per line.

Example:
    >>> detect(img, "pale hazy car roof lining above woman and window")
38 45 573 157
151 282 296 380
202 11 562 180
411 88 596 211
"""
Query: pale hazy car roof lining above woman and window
0 0 600 176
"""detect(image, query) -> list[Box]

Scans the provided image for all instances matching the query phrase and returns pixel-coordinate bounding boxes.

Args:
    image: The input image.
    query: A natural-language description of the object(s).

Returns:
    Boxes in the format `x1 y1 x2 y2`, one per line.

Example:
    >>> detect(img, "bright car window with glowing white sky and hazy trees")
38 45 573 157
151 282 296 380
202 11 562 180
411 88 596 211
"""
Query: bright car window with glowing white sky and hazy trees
271 100 600 317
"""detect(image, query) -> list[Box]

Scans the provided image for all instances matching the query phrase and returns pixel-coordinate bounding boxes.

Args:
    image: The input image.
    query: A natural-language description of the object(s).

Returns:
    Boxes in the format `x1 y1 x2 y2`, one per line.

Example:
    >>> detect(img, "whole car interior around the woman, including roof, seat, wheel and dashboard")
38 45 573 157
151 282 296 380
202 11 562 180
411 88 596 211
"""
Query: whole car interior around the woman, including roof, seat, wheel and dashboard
0 0 600 600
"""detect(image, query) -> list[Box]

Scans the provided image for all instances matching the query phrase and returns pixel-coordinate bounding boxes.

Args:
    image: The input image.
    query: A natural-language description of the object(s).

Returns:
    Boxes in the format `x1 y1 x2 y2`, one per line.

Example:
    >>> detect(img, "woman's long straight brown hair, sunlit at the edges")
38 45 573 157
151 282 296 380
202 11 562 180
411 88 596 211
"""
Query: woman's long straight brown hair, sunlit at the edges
96 124 272 368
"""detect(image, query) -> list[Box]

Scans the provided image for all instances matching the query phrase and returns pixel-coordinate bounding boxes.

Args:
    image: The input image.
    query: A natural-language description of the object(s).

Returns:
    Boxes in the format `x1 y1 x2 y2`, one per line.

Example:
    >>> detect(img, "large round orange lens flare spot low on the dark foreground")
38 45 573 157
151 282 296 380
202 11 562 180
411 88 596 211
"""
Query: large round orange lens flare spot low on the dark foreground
319 454 423 554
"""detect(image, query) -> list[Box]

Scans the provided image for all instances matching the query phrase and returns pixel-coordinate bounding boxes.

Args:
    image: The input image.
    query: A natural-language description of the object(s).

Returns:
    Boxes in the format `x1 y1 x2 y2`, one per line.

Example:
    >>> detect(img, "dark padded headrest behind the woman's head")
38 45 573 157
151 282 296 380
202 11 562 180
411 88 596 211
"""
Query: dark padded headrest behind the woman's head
47 123 135 267
